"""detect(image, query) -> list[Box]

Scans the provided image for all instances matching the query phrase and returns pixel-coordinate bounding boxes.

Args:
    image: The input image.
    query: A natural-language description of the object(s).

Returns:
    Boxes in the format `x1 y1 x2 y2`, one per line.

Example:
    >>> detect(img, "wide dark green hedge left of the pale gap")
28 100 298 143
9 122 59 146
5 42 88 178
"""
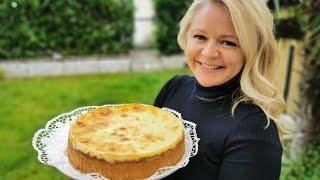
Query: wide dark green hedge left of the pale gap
0 0 134 58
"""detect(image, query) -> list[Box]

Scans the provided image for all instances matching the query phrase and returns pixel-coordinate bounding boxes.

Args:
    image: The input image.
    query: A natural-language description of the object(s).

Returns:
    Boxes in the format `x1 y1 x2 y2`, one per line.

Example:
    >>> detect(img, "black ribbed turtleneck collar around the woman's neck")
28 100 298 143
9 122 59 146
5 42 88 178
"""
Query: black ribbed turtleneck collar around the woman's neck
194 73 241 102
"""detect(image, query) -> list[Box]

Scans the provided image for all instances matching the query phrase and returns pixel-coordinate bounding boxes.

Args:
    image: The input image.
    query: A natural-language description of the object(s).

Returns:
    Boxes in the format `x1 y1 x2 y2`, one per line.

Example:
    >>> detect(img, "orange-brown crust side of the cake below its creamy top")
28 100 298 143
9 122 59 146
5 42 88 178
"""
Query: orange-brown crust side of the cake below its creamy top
67 137 185 180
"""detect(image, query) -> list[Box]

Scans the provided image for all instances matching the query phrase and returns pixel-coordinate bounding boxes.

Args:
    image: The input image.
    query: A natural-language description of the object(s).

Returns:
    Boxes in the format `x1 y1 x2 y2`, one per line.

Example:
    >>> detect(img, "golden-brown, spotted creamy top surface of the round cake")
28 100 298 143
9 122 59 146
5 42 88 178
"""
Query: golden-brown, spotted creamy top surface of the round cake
69 104 184 162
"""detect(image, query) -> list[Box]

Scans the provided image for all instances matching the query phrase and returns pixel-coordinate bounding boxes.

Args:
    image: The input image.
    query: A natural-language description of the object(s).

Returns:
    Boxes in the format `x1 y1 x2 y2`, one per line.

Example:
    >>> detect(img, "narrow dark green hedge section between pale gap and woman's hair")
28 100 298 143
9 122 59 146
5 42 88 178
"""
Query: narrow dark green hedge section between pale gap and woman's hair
153 0 192 54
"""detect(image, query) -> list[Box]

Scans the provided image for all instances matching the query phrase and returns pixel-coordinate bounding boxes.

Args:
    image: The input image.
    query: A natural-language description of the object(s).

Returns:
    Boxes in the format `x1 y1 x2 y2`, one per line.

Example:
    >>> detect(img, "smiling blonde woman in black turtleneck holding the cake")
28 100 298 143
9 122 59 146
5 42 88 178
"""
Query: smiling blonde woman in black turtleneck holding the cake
154 0 285 180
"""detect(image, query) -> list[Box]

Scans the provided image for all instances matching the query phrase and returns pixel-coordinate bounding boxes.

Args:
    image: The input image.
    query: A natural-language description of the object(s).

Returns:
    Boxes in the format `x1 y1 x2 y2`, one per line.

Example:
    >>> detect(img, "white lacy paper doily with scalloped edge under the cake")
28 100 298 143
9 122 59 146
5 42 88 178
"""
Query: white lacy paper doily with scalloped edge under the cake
32 105 200 180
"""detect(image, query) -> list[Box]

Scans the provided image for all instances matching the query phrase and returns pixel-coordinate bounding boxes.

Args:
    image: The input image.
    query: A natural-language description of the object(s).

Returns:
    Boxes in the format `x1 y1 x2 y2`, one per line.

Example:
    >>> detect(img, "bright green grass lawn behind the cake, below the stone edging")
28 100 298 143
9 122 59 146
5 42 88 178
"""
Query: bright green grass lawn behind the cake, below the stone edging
0 69 188 180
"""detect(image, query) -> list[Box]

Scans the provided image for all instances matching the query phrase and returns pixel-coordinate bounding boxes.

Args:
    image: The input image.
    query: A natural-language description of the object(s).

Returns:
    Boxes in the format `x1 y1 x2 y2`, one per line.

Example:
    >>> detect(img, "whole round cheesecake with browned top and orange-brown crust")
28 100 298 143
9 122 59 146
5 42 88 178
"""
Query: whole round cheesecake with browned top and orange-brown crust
67 104 185 179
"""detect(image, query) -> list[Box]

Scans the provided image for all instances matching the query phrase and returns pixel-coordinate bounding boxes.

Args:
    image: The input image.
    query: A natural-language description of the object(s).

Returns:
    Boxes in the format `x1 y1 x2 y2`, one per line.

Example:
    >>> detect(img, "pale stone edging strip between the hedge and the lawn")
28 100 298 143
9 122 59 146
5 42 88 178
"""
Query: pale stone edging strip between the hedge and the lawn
0 55 185 77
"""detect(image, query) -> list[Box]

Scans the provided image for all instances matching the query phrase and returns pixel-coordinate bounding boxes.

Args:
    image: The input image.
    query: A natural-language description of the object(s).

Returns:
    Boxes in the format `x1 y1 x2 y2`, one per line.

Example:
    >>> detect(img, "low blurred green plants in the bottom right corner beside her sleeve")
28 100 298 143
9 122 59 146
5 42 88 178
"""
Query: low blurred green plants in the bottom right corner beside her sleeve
281 140 320 180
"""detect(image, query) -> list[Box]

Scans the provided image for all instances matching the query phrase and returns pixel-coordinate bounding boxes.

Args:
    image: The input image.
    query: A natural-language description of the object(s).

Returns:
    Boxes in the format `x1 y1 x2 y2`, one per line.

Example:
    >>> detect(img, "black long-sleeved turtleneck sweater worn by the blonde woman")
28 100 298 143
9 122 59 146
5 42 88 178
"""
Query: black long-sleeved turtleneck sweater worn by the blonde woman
154 75 282 180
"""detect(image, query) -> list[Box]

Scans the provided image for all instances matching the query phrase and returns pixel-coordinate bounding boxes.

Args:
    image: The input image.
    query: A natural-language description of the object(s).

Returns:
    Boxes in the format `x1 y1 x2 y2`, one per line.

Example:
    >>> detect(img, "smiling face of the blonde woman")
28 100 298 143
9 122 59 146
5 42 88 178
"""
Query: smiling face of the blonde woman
185 3 245 87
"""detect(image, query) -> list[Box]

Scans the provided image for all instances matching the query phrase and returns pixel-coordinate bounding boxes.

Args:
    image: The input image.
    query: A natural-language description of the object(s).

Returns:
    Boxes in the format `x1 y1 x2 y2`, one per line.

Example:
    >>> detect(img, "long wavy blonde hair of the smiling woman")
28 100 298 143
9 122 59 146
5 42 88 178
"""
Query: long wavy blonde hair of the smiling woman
178 0 288 134
